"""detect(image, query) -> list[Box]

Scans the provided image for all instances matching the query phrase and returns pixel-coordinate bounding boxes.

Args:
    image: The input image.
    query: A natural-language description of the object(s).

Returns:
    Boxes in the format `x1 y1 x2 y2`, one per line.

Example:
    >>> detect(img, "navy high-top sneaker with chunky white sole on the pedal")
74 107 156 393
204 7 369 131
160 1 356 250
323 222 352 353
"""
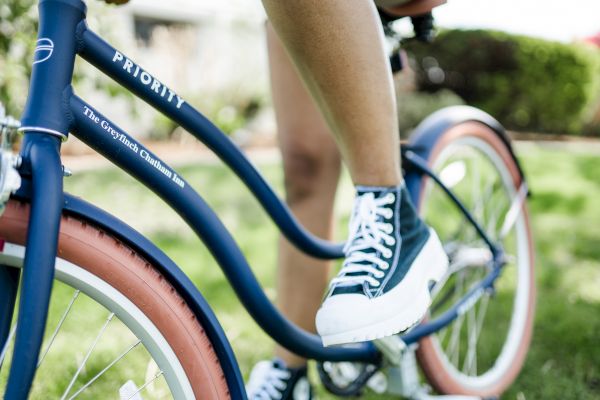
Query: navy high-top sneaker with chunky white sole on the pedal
316 185 448 346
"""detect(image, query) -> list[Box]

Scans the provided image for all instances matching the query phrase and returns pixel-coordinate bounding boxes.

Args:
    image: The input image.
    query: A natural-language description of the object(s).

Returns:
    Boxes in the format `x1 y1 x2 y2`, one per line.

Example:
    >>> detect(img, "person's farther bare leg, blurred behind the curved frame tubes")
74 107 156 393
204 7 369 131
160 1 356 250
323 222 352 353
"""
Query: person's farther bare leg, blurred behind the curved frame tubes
267 26 341 367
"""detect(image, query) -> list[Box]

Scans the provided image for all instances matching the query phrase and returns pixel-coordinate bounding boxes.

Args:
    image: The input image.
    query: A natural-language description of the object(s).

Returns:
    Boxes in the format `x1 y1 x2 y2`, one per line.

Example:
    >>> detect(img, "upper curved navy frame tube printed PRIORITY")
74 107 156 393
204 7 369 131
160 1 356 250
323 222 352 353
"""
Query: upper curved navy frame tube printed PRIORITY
78 21 343 259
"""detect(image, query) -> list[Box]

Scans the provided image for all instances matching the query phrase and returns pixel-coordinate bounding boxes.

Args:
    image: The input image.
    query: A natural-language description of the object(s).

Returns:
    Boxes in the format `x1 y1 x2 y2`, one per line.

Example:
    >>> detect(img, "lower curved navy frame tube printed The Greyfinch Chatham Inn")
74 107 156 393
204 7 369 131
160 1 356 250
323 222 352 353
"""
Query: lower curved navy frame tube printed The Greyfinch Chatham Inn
70 95 377 362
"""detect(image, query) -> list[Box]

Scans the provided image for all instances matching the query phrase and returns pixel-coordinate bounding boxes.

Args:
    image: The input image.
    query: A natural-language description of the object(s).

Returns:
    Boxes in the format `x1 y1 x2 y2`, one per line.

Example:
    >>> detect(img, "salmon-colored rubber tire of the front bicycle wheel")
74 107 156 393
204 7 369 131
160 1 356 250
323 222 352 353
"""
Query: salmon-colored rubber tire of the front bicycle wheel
0 200 230 400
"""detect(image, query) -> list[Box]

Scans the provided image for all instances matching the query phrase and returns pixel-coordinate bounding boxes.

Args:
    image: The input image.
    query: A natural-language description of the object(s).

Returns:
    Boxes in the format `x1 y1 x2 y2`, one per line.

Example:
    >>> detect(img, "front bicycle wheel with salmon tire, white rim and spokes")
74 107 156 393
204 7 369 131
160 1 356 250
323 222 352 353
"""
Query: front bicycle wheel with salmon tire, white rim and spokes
0 201 230 400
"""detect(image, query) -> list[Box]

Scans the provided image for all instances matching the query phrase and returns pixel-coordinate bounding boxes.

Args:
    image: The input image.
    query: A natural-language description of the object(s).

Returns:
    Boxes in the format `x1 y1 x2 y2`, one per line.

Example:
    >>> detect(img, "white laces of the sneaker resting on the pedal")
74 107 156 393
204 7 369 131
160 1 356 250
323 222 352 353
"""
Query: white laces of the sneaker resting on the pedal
331 193 396 287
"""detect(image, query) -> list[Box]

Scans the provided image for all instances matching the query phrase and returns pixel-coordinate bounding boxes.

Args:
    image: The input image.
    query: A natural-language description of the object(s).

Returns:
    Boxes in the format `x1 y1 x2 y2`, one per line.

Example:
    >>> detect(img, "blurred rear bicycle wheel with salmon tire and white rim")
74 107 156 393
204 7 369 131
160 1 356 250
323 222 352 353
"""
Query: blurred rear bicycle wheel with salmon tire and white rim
418 122 535 396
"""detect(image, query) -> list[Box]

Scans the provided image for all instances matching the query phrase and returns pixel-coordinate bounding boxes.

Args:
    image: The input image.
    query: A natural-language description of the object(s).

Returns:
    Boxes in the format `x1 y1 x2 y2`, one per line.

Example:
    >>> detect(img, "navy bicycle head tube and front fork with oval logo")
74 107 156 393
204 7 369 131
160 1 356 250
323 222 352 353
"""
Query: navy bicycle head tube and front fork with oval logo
0 0 86 400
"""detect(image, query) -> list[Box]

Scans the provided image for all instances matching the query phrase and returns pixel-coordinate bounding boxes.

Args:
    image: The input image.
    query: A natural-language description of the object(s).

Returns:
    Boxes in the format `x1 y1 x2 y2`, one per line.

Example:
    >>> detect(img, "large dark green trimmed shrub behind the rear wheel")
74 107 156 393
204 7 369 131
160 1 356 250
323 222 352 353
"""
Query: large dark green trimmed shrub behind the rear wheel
408 30 600 134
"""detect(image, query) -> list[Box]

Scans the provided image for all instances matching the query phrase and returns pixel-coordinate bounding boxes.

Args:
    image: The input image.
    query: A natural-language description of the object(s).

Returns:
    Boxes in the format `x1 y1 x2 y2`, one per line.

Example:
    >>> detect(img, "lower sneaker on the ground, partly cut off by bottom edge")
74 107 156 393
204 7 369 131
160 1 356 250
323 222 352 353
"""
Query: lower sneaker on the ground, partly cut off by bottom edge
246 359 314 400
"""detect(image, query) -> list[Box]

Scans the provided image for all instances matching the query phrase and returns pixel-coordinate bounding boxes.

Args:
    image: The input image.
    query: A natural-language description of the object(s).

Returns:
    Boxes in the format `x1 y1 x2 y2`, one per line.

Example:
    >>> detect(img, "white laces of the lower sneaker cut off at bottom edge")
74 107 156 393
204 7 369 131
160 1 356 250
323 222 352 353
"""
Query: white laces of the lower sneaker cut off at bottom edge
246 361 292 400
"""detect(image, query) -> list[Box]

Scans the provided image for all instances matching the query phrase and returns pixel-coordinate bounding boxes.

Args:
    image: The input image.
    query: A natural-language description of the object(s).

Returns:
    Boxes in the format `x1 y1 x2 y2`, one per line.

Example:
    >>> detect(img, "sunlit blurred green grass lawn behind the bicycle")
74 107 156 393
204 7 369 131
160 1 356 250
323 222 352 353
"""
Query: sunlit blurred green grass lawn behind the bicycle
3 144 600 400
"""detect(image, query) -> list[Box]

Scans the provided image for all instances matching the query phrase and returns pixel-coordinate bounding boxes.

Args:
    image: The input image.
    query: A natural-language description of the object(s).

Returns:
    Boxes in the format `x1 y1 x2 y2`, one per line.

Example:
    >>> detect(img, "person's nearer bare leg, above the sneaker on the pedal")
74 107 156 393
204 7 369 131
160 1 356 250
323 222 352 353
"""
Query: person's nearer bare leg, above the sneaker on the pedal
263 0 401 186
